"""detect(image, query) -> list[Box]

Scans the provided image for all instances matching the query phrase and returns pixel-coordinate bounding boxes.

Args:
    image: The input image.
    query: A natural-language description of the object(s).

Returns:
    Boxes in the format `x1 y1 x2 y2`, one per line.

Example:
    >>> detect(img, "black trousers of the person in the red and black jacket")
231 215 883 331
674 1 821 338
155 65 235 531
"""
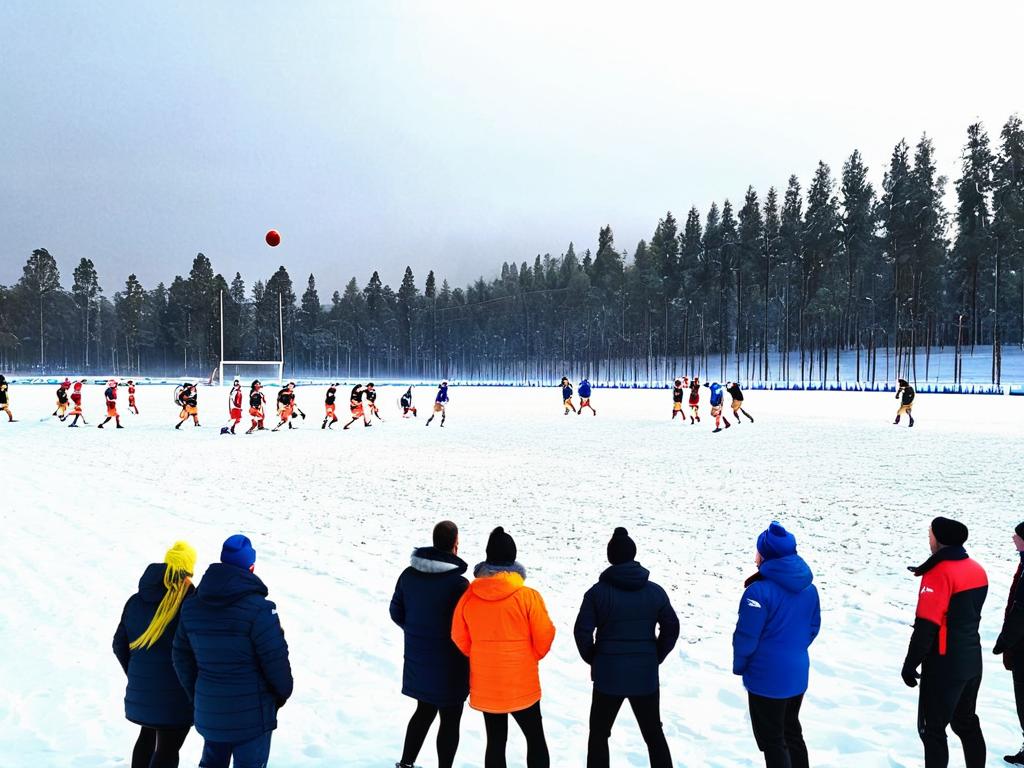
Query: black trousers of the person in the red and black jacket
918 674 985 768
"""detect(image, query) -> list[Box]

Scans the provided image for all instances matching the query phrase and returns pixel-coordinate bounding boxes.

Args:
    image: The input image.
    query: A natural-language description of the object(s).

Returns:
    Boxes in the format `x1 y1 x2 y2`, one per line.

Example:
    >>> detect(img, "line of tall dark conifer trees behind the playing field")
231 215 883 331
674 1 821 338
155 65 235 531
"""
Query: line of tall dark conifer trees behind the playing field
0 116 1024 383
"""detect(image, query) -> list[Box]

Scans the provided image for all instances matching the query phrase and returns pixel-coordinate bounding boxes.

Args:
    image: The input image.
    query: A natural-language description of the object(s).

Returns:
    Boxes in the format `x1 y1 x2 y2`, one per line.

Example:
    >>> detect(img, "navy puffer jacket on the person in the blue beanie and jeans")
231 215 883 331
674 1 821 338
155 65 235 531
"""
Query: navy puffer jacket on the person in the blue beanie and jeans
173 563 292 743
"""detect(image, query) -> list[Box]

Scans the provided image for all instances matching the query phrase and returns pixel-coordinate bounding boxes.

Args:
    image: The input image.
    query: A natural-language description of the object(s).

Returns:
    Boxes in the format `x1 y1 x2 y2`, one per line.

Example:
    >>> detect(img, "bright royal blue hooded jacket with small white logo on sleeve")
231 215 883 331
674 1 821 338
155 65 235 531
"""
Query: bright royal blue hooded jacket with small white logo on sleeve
732 555 821 698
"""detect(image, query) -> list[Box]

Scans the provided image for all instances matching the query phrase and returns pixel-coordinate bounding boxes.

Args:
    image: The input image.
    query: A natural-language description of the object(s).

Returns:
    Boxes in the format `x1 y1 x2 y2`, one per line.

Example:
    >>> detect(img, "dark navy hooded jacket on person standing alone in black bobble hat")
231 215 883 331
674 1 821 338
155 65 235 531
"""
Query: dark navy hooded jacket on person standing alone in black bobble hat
573 561 679 696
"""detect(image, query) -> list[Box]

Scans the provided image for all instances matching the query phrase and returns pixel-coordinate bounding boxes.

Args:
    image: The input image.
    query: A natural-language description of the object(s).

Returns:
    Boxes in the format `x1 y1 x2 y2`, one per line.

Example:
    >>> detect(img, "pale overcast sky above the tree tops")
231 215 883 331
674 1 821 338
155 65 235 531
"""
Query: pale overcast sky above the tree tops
0 0 1024 301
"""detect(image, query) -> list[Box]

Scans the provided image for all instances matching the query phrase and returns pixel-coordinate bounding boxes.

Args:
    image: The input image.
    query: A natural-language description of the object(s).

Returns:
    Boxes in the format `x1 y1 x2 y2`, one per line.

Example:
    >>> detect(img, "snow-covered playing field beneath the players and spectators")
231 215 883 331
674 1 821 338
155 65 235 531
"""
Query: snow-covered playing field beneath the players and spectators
0 386 1024 768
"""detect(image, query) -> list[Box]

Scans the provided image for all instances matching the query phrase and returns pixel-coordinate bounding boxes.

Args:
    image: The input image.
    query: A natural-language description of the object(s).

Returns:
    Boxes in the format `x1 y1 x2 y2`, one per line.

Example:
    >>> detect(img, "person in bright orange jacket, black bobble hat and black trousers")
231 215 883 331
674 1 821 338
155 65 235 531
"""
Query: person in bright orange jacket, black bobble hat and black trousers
452 526 555 768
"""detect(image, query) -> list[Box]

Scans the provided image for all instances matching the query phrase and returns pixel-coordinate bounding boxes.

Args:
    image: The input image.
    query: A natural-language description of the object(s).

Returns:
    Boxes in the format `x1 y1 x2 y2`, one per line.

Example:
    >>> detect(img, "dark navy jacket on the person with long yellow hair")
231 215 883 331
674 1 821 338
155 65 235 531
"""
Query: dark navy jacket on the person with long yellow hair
114 562 195 728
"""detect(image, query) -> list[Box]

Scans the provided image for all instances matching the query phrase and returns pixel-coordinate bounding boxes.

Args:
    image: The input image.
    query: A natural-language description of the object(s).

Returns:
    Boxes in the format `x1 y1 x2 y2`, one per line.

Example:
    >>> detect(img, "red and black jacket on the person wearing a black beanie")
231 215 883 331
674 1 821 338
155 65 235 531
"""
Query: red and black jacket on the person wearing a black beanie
904 547 988 680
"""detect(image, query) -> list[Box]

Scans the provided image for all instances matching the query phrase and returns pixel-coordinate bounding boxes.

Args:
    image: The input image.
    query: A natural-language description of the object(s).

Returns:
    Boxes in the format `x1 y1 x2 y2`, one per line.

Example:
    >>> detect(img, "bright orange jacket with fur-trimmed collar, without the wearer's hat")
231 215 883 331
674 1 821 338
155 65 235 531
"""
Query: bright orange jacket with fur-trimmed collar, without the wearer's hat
452 563 555 714
